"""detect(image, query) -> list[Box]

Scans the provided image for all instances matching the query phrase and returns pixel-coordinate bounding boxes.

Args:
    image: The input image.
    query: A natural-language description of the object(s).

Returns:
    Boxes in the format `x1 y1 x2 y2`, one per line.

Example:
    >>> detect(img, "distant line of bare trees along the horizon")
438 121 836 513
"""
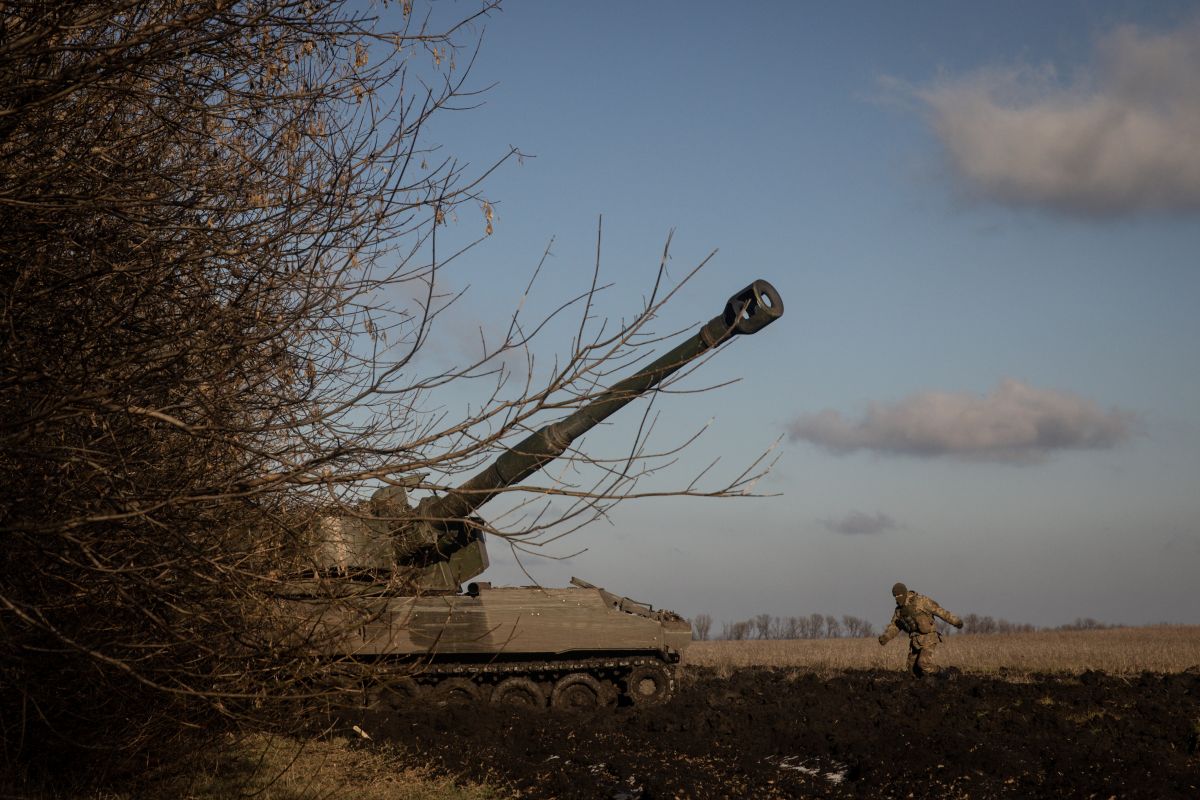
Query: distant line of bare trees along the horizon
691 614 1121 642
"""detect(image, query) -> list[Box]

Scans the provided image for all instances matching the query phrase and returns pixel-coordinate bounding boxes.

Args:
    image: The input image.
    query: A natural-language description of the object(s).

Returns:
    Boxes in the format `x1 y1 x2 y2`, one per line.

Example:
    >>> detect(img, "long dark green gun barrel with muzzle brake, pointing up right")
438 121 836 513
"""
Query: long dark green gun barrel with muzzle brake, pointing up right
419 279 784 521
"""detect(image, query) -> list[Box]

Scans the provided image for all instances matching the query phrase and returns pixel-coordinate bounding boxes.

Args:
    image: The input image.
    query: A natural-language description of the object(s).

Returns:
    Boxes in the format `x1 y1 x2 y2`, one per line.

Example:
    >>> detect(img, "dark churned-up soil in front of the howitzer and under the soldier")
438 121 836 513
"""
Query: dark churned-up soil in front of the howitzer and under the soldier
364 668 1200 800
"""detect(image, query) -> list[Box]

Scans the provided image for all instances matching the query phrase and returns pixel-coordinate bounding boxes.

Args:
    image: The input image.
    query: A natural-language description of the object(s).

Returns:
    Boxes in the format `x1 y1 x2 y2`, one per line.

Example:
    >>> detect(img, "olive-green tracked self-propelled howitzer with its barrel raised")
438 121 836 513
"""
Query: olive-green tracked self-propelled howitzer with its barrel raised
300 281 784 708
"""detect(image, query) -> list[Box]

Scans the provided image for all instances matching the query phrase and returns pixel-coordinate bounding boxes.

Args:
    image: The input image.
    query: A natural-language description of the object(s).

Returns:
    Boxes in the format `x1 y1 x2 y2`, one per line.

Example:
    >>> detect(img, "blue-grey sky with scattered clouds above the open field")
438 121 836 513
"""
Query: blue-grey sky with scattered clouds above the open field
374 1 1200 631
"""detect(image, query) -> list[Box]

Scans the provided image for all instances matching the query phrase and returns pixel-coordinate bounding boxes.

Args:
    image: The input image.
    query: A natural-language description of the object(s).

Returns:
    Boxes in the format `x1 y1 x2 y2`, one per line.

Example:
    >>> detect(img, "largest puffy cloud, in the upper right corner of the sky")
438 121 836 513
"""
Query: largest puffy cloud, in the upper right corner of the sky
917 18 1200 215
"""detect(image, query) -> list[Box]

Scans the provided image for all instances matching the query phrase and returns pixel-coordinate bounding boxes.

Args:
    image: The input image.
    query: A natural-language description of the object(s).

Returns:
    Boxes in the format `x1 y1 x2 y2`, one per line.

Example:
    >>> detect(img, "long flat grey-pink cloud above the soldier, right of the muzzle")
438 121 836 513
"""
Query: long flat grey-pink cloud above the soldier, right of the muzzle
788 379 1133 463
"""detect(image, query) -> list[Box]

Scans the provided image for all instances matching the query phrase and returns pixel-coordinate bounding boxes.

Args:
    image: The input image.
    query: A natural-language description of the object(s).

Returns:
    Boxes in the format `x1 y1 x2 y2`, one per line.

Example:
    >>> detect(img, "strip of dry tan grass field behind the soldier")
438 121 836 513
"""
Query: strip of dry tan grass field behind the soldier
685 625 1200 675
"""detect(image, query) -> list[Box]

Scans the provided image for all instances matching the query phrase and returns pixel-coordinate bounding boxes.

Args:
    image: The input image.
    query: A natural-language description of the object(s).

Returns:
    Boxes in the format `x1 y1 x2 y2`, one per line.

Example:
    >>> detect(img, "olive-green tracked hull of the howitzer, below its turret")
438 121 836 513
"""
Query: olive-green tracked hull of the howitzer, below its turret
286 581 691 710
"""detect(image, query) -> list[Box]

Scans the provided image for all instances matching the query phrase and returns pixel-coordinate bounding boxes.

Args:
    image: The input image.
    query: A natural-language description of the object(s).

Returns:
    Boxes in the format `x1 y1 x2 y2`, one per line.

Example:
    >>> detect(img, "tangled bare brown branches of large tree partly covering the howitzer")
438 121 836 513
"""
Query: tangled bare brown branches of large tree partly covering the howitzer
0 0 777 775
